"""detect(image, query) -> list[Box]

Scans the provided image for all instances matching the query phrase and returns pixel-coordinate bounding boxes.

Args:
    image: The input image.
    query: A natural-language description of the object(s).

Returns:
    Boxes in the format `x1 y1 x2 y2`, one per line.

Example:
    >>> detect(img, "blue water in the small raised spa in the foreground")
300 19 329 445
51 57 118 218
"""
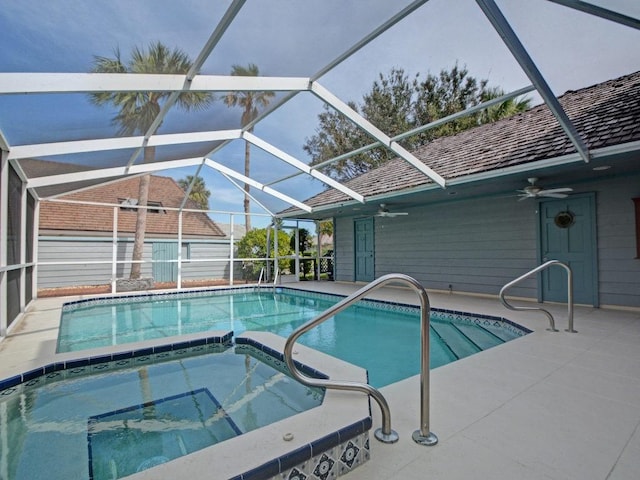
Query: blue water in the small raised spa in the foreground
0 348 323 480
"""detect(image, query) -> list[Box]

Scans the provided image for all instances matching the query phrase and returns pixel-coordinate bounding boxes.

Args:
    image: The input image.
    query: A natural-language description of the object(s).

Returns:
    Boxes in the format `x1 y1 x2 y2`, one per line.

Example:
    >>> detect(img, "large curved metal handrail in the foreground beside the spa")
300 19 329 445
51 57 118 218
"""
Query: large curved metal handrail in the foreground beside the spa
284 273 438 445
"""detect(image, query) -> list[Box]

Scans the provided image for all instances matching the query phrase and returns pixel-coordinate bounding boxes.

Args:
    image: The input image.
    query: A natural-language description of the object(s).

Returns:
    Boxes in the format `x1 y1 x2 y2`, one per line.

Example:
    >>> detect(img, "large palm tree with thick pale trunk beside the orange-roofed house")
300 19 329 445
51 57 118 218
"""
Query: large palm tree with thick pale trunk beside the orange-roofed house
90 42 213 279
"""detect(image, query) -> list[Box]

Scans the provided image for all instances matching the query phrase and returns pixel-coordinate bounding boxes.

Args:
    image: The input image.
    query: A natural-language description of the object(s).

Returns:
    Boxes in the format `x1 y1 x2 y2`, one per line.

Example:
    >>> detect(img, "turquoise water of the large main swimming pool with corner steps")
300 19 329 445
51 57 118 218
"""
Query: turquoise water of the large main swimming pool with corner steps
58 288 526 387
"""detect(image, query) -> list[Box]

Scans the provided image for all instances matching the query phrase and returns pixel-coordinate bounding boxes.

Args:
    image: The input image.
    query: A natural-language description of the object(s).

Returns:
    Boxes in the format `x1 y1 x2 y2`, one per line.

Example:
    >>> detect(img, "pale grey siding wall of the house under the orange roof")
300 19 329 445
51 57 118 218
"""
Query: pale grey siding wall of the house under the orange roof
38 236 241 288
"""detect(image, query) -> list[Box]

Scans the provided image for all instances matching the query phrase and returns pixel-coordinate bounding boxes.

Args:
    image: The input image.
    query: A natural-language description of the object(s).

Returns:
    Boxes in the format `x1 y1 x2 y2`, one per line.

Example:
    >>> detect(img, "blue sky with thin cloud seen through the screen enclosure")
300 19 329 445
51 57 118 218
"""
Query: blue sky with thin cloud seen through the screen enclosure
0 0 640 229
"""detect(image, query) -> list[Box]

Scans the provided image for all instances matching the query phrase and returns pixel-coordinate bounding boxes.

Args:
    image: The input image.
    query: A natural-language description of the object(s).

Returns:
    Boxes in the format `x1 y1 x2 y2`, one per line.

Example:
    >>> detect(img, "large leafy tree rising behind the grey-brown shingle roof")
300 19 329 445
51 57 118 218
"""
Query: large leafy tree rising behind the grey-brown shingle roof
303 64 529 180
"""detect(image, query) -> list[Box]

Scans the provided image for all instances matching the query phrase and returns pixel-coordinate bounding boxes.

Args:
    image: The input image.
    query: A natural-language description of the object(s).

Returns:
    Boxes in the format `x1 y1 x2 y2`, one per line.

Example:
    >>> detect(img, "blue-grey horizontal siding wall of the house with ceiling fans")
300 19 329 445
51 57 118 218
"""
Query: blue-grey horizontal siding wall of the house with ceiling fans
335 176 640 307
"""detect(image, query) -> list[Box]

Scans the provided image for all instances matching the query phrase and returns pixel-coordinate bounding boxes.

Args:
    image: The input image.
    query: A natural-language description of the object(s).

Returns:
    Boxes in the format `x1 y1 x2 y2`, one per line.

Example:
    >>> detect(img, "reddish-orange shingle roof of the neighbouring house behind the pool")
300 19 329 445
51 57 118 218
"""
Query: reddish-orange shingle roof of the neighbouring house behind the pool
40 175 225 237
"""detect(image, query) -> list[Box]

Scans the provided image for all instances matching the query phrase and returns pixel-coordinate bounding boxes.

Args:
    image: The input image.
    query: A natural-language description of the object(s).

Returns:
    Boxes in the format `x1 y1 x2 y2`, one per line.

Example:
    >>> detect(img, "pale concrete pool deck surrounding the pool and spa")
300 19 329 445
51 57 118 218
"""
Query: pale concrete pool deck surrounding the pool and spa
0 282 640 480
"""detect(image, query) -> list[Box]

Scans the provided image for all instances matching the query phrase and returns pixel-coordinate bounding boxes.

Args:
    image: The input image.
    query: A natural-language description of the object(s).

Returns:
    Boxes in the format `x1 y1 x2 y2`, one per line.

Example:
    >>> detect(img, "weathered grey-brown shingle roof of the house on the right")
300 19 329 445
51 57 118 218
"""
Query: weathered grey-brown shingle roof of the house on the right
300 72 640 211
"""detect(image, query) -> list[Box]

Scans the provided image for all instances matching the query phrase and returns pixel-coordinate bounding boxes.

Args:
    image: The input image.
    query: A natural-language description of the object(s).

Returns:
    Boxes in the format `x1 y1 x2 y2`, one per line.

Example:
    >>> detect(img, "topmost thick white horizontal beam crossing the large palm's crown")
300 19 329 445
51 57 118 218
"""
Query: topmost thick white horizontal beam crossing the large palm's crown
0 73 309 94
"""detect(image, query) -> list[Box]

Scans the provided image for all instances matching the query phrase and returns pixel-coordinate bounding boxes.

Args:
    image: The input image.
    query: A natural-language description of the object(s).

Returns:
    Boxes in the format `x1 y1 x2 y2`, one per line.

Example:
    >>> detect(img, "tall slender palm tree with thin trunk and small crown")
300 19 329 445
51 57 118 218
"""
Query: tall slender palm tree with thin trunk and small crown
224 63 275 232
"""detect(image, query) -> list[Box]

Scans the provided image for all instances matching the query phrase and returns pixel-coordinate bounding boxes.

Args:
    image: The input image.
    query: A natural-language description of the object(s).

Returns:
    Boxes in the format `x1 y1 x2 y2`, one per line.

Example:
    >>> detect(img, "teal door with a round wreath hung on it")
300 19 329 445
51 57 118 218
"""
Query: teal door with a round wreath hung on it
540 194 598 307
